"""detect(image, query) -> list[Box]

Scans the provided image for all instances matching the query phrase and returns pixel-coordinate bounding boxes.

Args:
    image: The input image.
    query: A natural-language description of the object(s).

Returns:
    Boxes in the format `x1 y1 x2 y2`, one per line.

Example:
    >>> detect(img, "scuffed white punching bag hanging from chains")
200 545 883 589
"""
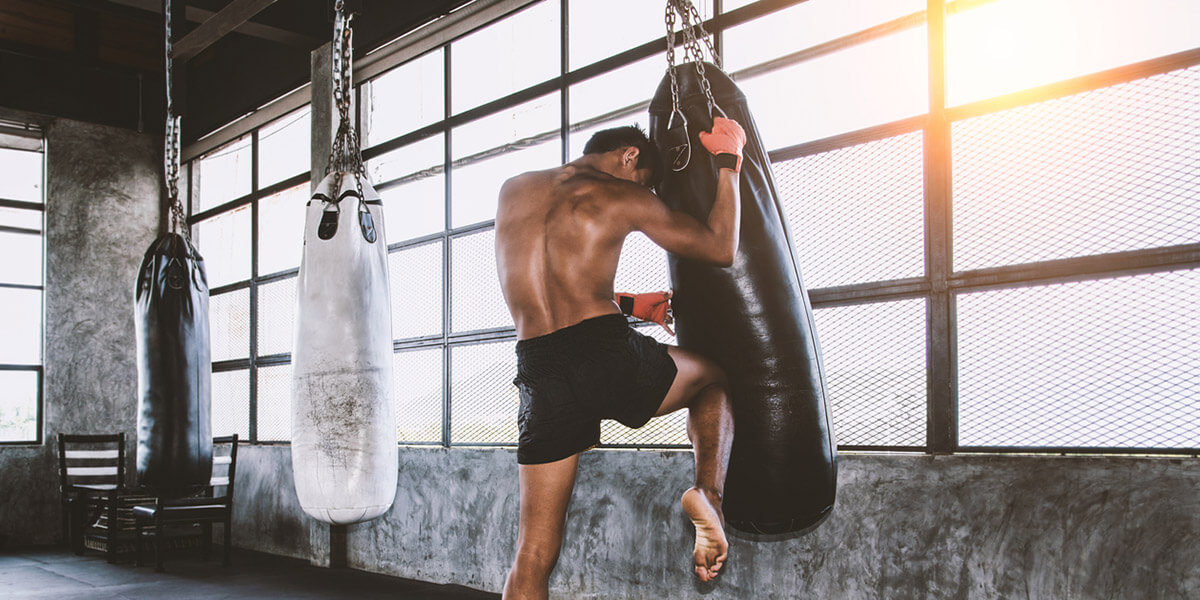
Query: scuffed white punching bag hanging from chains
292 170 397 524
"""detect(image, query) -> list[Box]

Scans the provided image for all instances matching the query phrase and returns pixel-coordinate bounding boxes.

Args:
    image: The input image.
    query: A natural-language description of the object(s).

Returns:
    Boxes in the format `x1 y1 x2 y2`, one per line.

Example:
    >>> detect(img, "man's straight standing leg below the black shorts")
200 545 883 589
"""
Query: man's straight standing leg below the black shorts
504 454 580 600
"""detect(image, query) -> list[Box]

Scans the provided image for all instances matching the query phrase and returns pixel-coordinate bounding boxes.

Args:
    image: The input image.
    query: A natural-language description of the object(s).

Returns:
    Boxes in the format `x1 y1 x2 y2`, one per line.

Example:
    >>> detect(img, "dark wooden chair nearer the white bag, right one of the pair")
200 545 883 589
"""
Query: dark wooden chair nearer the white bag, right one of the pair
133 434 238 571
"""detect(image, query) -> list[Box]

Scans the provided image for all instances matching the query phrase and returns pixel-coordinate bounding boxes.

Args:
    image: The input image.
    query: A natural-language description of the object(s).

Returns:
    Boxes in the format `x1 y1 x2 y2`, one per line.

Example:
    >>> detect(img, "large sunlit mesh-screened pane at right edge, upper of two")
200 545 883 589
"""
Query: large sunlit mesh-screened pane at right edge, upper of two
953 67 1200 271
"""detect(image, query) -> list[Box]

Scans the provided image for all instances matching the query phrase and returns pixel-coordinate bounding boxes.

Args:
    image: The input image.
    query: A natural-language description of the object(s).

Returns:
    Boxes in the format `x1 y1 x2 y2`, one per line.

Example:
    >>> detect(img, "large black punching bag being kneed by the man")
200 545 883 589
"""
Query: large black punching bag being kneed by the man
650 62 838 534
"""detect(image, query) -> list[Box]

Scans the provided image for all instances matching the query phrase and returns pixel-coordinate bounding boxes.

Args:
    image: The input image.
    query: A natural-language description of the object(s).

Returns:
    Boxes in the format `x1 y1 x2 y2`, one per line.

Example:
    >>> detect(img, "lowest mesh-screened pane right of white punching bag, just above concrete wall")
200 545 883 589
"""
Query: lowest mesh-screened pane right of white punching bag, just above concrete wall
391 346 444 442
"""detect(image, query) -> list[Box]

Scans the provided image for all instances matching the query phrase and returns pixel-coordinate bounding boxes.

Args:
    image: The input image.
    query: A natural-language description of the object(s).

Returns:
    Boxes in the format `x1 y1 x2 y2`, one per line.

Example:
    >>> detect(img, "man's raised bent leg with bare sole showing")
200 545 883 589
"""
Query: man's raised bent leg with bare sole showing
654 347 733 581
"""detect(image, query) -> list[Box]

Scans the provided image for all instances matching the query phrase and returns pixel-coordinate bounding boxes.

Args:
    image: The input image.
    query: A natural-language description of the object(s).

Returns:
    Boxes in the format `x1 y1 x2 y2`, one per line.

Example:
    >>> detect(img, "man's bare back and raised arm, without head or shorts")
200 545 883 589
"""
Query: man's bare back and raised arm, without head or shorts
496 140 740 340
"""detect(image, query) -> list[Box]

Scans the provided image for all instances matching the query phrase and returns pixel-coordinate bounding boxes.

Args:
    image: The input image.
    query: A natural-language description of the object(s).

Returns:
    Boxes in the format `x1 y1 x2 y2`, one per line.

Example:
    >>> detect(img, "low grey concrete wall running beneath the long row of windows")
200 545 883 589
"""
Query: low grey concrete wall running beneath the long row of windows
234 448 1200 600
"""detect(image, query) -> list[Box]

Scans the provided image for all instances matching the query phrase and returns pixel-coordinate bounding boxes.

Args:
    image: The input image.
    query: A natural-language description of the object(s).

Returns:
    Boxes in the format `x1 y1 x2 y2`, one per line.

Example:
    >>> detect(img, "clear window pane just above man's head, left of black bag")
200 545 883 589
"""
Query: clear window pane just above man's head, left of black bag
570 55 666 127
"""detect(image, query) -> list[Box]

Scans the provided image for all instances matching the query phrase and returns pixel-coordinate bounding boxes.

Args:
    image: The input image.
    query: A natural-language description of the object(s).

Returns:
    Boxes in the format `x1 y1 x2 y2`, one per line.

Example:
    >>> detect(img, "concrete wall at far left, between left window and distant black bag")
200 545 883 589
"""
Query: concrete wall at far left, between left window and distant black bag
0 119 162 545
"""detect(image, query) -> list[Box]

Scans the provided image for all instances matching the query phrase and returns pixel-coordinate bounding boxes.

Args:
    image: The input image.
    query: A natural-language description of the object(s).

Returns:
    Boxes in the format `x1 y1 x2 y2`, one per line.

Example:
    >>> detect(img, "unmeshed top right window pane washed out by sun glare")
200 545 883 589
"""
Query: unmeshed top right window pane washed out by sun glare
946 0 1200 104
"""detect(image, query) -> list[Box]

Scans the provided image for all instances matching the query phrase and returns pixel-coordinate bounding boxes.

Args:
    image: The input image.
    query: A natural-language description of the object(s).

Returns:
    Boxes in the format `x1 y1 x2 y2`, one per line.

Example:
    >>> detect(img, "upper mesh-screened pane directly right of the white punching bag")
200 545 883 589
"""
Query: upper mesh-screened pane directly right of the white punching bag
388 240 443 340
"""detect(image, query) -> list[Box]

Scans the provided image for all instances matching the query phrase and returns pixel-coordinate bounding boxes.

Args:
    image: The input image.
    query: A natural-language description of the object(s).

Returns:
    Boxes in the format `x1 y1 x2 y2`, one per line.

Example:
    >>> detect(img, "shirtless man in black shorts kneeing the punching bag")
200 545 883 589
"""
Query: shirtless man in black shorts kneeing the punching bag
496 119 745 600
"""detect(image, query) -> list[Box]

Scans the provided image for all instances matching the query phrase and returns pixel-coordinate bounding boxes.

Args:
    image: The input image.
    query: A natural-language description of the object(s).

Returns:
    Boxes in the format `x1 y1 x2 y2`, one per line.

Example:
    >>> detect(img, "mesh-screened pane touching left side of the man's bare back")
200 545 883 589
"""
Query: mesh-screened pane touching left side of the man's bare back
450 229 512 333
